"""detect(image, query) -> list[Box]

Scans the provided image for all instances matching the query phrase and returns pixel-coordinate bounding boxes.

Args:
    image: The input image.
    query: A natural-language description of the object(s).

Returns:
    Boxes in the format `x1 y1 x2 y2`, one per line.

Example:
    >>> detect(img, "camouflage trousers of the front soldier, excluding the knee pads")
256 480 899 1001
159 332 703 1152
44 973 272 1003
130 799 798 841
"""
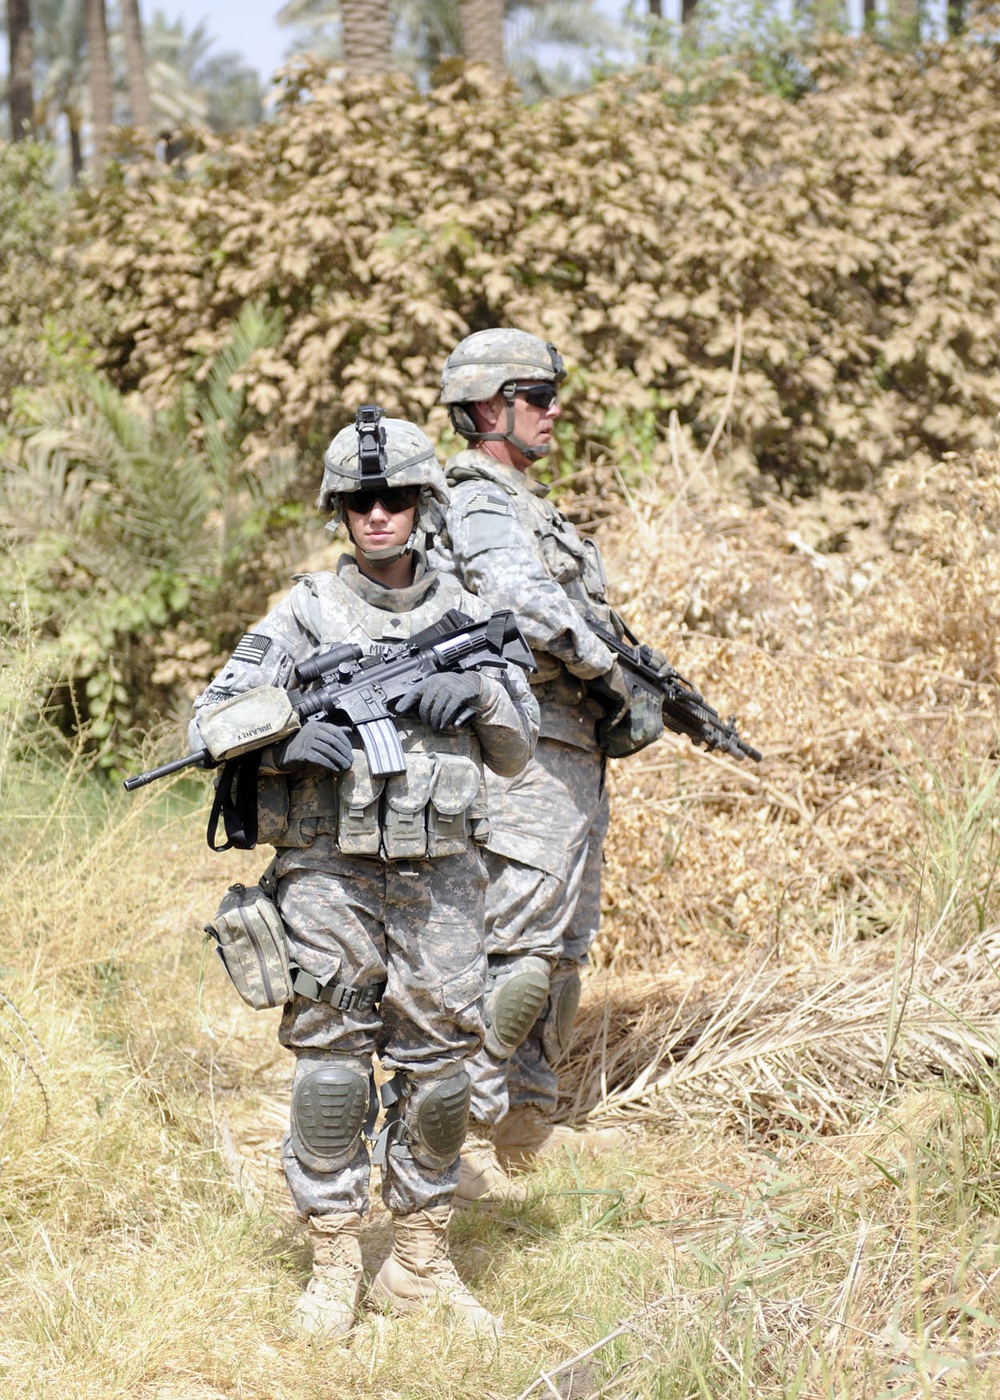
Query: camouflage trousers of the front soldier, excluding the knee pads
277 840 486 1215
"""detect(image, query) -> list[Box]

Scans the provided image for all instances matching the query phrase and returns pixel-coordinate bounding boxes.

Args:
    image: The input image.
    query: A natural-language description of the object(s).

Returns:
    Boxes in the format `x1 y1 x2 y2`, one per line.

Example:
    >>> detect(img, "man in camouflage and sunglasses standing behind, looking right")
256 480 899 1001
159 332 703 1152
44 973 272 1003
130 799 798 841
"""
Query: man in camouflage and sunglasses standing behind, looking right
433 329 627 1204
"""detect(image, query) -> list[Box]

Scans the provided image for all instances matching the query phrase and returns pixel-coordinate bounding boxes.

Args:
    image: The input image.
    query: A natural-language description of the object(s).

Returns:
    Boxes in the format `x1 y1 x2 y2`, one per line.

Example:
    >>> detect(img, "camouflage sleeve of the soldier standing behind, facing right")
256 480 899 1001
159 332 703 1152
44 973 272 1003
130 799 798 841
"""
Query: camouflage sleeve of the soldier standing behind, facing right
448 480 615 680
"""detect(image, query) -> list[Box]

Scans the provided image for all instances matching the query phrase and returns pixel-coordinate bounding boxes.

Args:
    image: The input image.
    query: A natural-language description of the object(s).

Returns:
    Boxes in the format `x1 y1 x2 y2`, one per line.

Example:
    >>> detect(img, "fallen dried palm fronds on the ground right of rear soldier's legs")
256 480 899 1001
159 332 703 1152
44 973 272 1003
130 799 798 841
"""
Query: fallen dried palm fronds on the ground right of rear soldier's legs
564 930 1000 1137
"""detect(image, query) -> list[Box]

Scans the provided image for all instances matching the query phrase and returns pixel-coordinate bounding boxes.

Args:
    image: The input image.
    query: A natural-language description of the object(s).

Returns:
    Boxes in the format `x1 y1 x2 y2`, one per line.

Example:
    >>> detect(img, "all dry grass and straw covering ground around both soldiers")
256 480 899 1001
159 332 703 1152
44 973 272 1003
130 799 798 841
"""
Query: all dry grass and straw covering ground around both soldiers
0 435 1000 1400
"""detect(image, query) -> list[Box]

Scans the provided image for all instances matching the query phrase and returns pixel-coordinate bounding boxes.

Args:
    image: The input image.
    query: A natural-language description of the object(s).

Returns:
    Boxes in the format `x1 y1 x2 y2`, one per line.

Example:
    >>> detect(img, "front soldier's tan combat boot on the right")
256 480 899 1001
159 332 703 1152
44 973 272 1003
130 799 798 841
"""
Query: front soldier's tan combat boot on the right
371 1205 500 1336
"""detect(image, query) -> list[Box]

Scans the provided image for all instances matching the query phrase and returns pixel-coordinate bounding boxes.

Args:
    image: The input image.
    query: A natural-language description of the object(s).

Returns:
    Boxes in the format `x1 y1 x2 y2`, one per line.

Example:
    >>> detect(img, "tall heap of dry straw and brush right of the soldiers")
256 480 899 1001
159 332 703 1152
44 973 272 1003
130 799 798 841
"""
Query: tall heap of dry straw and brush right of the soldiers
567 440 1000 1131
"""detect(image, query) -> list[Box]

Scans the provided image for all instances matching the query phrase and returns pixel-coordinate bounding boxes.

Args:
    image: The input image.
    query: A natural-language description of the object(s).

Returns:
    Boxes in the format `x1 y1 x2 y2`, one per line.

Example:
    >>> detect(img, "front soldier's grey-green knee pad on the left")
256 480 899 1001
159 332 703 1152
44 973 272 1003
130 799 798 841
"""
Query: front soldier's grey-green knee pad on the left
290 1058 371 1172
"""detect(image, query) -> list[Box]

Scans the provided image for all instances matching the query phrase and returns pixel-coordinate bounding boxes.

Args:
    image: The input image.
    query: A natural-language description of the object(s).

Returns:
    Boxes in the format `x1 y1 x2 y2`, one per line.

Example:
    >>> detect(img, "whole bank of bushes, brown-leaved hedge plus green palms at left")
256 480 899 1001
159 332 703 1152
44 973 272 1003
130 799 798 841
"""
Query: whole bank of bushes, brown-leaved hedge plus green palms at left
0 30 1000 746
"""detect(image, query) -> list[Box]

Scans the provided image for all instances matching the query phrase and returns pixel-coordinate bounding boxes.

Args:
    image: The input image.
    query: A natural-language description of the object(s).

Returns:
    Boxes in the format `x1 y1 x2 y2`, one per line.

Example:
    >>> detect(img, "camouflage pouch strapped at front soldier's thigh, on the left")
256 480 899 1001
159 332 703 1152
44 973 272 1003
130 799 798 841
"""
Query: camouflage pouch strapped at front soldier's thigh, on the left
204 869 291 1011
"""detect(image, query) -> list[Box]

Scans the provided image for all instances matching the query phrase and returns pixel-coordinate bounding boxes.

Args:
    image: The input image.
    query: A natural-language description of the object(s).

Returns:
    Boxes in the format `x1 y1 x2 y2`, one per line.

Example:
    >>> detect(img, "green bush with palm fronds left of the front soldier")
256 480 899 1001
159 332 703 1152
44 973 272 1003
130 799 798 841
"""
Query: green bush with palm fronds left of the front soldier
0 308 300 766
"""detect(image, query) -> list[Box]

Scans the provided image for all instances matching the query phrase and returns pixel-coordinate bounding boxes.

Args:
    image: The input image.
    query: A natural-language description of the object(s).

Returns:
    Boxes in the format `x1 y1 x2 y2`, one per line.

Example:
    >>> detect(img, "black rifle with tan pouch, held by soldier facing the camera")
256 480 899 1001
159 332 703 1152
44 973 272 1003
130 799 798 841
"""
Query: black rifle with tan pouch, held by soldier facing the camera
125 608 535 792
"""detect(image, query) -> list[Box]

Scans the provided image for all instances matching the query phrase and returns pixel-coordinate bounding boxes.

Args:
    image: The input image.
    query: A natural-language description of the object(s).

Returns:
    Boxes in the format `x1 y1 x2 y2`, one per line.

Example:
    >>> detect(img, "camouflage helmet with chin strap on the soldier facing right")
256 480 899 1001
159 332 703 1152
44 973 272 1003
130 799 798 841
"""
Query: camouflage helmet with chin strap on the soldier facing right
441 326 566 459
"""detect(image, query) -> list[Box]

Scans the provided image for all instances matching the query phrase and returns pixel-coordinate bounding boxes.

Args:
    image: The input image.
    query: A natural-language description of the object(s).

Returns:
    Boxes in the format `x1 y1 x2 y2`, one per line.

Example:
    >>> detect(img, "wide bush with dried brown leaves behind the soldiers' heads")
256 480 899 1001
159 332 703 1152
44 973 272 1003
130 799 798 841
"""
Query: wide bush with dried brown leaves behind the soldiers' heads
60 39 1000 486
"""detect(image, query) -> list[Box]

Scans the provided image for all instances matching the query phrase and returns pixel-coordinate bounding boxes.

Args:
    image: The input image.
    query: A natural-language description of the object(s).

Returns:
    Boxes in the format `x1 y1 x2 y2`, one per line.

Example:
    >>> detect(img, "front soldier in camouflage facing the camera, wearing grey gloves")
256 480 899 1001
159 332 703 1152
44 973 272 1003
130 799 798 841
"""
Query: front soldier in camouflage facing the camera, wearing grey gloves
190 414 538 1336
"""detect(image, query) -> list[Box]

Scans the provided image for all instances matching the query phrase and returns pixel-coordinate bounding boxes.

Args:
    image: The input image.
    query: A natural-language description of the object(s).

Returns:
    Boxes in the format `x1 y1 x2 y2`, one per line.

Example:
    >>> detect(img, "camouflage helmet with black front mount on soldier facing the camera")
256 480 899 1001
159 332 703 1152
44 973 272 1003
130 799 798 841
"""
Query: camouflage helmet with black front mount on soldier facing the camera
319 403 448 560
